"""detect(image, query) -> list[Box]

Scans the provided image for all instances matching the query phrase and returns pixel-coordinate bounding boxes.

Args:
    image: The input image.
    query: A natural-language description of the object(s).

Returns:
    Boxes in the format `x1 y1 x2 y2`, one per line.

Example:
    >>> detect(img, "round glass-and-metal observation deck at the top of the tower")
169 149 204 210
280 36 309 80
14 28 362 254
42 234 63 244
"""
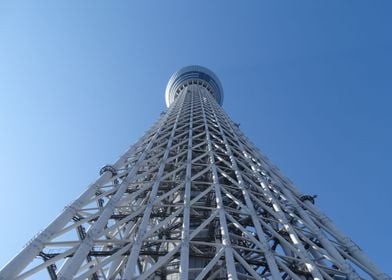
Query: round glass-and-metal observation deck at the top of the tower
165 65 223 107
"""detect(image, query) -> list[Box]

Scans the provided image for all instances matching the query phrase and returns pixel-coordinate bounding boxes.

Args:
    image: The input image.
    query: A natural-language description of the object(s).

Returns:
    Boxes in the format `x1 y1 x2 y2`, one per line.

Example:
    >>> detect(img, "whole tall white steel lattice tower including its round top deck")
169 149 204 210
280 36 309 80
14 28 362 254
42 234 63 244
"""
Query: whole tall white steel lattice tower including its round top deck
0 66 390 280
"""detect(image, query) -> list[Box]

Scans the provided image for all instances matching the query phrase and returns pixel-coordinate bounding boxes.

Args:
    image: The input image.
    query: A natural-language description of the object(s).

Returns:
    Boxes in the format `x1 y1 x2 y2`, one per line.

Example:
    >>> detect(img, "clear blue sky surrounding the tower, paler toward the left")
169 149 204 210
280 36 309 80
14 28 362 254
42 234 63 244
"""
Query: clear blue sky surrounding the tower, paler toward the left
0 0 392 274
